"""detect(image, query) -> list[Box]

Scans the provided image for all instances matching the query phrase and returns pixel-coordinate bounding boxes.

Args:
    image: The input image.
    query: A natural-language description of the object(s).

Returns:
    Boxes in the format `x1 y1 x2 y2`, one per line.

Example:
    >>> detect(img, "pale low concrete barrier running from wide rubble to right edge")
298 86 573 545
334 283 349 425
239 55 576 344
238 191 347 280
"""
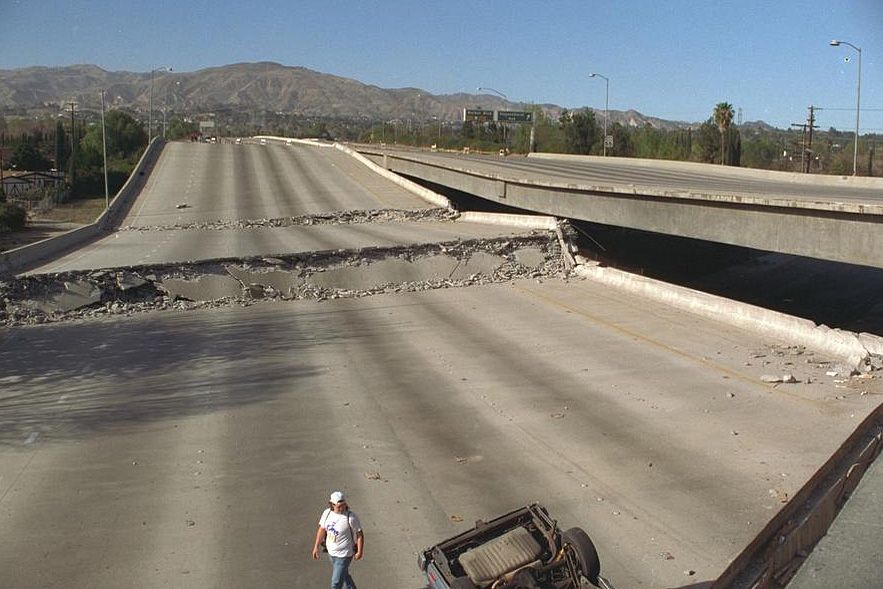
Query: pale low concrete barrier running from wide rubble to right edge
575 263 883 369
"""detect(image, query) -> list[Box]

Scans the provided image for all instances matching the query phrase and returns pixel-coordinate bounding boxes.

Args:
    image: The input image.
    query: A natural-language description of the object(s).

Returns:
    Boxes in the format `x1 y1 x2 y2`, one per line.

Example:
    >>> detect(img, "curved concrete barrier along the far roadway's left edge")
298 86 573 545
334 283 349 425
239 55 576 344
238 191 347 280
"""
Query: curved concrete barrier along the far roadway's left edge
0 138 165 276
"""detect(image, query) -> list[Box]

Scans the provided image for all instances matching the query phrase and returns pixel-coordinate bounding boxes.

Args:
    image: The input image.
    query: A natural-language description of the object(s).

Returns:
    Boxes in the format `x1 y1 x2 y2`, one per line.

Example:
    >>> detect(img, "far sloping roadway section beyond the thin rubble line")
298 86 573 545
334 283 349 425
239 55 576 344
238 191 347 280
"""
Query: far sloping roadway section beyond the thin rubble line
129 142 430 227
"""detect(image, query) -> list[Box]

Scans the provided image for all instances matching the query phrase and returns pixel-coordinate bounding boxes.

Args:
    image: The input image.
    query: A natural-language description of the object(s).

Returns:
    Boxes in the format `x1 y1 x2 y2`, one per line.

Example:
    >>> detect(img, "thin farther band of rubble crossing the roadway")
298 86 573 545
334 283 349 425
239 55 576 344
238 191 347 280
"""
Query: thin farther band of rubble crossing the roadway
119 208 459 231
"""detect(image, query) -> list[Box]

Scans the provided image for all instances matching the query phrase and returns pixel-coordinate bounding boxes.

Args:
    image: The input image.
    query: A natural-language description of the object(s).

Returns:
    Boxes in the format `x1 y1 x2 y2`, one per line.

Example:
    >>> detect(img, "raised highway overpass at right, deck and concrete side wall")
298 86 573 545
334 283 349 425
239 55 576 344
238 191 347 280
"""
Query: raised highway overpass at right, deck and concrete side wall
359 147 883 268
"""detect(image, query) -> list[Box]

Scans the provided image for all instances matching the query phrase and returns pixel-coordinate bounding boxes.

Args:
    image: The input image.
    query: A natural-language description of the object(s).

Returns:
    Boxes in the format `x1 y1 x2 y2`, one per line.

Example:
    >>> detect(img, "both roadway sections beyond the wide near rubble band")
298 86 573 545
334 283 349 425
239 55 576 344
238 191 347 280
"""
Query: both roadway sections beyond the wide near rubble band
32 143 524 273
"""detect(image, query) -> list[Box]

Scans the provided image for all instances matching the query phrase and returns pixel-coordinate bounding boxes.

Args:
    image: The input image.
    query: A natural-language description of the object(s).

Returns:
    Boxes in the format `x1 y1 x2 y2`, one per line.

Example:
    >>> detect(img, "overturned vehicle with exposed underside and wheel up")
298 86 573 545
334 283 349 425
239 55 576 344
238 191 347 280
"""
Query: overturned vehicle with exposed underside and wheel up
418 503 613 589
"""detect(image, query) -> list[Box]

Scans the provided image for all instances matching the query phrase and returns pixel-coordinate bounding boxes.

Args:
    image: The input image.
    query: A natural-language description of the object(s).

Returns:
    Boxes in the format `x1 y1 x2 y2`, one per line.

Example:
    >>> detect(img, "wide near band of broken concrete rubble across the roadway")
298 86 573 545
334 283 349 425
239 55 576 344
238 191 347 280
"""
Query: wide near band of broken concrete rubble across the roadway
0 231 567 326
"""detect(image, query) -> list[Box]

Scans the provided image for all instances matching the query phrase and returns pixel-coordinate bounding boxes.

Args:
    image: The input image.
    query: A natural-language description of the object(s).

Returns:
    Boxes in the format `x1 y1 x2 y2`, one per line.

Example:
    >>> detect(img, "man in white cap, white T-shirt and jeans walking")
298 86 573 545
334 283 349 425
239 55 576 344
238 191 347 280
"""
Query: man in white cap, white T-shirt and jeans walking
313 491 365 589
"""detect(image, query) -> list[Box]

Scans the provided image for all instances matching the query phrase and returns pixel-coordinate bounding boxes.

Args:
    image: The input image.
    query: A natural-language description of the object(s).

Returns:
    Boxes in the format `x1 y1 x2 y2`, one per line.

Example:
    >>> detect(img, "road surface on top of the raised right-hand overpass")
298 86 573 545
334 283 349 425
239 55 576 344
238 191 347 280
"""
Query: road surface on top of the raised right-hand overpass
384 151 883 214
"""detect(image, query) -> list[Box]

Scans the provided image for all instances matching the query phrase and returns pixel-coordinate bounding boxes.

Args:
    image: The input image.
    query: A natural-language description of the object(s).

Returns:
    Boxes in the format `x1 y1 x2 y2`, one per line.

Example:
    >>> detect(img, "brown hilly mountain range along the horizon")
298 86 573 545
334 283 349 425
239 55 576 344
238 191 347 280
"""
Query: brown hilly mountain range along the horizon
0 62 772 130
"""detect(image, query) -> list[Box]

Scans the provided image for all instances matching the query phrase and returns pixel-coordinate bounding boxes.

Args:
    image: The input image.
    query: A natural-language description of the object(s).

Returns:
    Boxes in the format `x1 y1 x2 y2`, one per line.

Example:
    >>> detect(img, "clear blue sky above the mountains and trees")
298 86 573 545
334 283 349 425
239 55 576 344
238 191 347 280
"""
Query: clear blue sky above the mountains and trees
0 0 883 132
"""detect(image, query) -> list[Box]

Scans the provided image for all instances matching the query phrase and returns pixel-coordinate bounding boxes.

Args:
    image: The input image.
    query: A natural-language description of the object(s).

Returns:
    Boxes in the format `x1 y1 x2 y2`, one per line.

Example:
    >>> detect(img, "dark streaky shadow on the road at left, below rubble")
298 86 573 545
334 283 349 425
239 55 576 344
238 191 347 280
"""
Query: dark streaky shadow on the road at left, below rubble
0 309 358 448
